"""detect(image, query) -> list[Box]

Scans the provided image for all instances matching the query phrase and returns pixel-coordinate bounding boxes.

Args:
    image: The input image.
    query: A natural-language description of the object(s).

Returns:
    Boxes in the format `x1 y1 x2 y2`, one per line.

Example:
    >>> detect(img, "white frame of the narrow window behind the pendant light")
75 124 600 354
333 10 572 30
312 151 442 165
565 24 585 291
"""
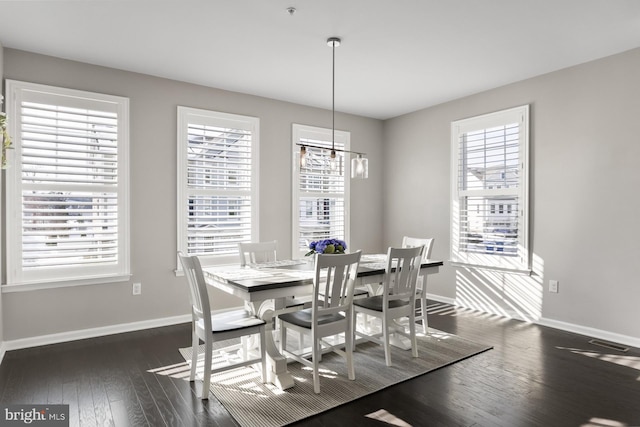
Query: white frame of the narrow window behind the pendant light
291 123 351 258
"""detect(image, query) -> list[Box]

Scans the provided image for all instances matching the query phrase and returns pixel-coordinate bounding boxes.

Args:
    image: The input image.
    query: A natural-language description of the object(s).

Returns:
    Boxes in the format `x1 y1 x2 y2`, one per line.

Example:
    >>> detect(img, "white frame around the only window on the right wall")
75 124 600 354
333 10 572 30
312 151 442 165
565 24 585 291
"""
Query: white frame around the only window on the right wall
450 105 531 274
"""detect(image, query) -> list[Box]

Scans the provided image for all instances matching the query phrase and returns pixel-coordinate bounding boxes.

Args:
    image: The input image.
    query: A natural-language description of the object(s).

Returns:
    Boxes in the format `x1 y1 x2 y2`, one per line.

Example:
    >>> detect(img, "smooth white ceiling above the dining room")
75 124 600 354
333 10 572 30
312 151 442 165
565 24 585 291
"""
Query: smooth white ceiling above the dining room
0 0 640 119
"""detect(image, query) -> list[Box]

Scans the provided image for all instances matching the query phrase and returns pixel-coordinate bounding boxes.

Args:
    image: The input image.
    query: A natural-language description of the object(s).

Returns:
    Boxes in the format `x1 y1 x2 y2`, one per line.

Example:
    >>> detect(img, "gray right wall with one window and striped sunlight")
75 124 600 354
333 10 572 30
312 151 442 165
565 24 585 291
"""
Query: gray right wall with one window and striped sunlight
383 49 640 346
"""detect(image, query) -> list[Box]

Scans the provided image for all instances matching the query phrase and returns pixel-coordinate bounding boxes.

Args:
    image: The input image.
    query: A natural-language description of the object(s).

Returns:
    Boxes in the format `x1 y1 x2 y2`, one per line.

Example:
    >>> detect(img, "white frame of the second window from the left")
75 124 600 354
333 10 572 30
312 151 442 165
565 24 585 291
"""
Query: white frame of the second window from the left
176 106 260 268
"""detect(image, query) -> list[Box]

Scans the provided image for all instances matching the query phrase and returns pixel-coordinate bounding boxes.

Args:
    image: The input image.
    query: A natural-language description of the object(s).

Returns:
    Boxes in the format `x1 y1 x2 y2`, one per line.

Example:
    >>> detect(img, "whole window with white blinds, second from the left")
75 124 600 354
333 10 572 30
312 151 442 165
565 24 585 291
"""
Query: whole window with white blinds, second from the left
178 107 260 264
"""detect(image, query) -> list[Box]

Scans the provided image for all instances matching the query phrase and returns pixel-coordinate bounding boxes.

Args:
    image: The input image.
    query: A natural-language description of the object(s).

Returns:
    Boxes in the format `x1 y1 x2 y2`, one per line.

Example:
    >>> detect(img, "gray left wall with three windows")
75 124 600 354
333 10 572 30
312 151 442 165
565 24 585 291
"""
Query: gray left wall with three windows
2 49 382 341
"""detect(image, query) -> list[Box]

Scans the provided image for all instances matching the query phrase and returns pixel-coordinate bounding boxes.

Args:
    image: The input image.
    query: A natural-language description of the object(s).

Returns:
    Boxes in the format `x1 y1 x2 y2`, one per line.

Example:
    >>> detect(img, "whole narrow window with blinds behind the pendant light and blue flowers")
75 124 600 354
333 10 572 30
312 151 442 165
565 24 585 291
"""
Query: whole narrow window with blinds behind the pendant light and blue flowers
292 124 350 257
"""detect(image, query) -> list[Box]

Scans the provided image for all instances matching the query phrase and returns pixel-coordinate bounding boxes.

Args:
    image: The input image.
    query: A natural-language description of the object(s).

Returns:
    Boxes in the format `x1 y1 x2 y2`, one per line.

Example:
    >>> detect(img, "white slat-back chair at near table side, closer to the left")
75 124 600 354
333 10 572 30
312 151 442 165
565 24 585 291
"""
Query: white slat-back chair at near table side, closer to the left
278 251 361 393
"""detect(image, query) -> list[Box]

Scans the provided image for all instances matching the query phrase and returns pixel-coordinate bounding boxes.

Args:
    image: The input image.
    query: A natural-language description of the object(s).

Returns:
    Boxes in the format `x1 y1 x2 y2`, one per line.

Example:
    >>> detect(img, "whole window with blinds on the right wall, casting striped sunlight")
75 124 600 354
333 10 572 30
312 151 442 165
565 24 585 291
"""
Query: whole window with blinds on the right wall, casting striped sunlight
451 106 529 270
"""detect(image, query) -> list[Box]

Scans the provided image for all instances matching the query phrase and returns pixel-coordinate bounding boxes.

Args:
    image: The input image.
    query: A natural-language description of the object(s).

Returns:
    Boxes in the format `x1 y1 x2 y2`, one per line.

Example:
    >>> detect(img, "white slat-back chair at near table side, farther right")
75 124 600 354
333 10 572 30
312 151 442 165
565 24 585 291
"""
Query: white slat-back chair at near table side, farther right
353 246 424 366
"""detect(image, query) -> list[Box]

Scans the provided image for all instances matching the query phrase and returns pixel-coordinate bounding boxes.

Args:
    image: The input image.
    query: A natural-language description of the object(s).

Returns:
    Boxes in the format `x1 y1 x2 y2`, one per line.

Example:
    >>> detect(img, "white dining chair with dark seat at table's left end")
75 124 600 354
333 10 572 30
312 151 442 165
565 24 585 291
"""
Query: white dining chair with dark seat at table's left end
178 252 267 400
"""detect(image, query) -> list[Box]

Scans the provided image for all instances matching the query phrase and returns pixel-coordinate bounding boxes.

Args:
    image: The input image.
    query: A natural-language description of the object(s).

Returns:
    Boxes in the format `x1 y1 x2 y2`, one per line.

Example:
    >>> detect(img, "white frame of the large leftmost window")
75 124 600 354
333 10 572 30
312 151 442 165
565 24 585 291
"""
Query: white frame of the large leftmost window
2 80 131 292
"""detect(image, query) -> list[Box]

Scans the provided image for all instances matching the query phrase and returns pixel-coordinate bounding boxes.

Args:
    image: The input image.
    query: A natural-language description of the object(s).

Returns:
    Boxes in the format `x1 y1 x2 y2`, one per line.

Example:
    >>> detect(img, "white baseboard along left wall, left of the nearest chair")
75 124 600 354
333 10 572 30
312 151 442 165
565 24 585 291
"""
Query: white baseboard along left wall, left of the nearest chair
0 314 191 352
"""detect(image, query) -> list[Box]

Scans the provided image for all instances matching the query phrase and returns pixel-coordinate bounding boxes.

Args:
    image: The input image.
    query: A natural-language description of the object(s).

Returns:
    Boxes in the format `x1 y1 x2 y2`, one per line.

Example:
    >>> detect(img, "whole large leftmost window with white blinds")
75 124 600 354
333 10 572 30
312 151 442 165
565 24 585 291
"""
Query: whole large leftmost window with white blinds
7 81 129 286
